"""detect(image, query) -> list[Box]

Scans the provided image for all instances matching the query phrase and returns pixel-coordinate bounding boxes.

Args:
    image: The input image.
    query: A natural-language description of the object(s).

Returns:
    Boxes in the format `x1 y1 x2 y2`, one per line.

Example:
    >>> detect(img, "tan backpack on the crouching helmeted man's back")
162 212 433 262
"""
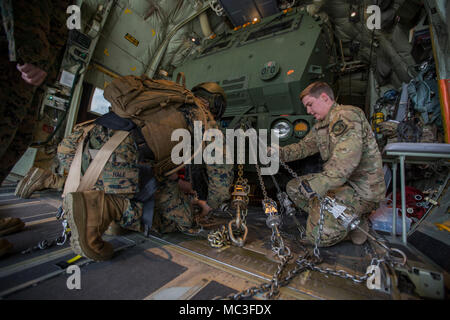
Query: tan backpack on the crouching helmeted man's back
103 73 214 180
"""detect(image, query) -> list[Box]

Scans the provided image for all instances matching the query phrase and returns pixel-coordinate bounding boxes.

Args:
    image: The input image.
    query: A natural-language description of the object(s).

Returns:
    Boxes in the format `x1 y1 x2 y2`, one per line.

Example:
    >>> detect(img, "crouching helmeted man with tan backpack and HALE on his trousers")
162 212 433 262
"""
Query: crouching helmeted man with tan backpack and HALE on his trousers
17 76 233 261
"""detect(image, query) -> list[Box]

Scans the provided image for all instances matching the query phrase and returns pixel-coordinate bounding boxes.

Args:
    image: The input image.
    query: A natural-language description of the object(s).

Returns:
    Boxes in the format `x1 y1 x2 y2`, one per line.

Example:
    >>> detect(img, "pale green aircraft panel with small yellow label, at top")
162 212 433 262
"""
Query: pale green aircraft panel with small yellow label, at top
89 0 200 80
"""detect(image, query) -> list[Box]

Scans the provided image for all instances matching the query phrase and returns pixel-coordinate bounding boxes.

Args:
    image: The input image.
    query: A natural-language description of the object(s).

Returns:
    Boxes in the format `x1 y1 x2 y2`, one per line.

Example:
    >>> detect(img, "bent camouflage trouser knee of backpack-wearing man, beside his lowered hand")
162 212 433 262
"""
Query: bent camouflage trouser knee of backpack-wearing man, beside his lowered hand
153 180 194 233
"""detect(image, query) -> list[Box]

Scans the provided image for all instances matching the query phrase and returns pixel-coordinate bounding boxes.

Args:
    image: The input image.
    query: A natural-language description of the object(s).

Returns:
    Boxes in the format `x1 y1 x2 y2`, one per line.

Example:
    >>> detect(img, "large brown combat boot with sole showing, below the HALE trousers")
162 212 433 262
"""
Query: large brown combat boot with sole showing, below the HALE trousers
63 190 126 261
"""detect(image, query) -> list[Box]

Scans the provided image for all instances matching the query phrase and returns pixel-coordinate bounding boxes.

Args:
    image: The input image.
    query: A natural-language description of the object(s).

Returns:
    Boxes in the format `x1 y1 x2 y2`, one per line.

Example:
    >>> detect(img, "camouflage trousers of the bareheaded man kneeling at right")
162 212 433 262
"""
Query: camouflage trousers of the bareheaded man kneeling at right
286 177 378 247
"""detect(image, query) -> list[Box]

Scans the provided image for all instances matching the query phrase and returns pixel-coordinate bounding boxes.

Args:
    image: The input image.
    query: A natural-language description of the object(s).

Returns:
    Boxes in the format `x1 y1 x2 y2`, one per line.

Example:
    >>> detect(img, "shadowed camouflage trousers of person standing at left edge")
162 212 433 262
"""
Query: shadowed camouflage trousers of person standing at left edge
0 58 40 184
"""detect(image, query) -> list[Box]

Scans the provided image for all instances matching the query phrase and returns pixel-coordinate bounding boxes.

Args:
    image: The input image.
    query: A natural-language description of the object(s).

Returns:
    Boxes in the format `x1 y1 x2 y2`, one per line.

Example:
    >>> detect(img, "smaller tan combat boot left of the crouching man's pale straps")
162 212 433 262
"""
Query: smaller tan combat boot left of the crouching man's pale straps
15 168 66 199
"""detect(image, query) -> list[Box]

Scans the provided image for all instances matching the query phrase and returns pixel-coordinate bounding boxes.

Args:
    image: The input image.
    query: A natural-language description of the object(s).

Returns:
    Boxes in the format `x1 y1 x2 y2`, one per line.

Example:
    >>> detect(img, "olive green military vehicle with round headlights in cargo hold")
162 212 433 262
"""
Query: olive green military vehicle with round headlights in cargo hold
173 8 332 145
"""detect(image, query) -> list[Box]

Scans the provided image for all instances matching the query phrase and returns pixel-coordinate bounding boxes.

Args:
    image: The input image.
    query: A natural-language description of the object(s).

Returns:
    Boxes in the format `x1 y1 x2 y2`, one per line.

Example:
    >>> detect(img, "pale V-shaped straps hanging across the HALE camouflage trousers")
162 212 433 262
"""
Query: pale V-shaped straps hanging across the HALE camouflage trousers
63 124 130 197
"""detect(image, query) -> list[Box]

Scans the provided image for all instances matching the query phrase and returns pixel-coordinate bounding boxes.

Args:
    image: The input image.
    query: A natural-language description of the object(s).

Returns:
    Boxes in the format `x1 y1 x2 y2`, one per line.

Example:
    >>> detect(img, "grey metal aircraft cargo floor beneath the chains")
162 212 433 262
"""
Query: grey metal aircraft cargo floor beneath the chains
0 184 446 300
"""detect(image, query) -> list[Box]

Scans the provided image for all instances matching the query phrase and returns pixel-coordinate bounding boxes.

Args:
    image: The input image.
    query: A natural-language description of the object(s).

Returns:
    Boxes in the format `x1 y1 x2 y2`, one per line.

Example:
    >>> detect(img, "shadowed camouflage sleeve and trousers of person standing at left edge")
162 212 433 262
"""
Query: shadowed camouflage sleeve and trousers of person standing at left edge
0 0 71 183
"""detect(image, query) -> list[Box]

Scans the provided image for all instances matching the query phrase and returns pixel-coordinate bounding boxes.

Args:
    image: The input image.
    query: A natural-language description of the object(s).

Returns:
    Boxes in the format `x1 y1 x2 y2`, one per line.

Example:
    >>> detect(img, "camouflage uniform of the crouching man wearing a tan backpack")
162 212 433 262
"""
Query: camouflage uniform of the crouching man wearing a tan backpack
58 105 233 233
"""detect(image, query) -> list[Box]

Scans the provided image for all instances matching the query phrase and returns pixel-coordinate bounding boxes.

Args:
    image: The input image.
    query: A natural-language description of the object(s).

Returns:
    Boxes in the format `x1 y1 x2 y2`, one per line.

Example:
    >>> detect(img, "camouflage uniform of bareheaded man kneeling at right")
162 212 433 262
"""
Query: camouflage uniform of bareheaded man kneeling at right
280 104 386 247
